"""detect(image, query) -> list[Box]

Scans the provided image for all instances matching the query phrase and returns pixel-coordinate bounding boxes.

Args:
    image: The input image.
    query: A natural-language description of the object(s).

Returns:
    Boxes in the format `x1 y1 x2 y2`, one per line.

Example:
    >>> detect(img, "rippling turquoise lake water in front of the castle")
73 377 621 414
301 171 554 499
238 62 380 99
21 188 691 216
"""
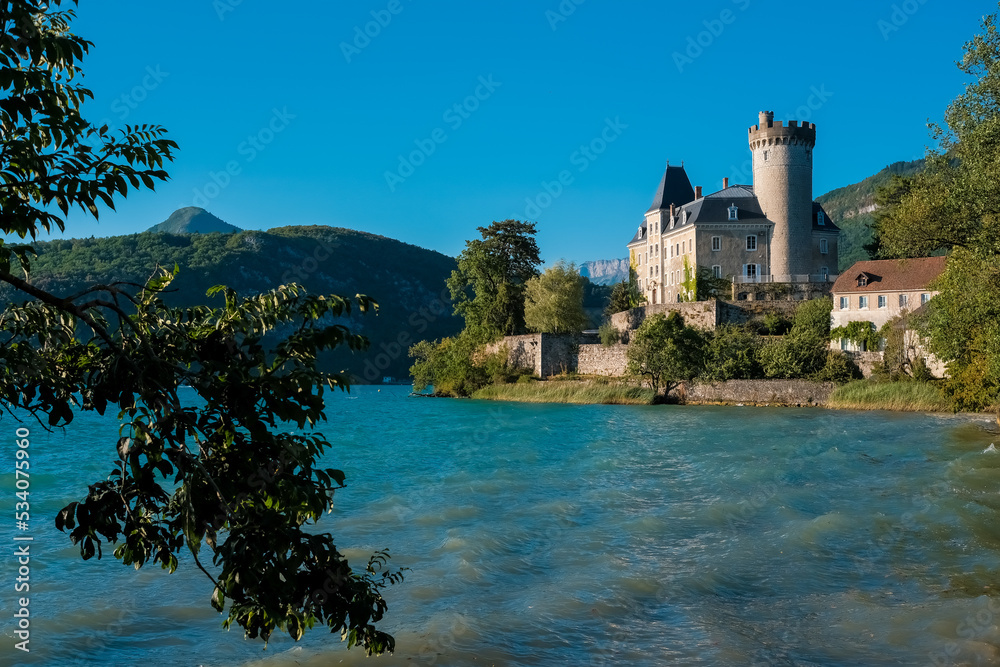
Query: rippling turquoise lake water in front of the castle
0 387 1000 666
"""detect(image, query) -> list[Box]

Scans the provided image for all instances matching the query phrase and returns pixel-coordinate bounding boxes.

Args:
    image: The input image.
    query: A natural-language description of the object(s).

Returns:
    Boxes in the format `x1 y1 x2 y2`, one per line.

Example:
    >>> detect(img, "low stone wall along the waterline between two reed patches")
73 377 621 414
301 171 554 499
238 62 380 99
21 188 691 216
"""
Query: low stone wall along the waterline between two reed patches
673 380 836 406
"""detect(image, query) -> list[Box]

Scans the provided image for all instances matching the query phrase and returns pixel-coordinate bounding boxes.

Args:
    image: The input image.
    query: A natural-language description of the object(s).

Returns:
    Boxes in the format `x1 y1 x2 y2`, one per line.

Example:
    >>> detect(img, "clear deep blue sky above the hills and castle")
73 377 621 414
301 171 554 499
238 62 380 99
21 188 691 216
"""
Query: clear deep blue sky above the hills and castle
48 0 997 262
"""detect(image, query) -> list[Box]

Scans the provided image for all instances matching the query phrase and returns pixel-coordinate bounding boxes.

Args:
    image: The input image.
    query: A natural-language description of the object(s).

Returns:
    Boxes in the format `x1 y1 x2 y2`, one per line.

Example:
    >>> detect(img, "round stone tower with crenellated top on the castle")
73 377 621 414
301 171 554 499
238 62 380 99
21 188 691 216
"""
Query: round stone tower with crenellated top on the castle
750 111 816 282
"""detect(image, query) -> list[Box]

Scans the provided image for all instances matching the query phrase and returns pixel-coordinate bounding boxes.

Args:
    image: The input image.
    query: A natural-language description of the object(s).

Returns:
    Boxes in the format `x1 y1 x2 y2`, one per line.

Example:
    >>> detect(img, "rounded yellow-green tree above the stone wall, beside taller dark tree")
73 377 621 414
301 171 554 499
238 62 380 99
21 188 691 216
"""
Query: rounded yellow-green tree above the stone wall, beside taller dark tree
524 261 588 334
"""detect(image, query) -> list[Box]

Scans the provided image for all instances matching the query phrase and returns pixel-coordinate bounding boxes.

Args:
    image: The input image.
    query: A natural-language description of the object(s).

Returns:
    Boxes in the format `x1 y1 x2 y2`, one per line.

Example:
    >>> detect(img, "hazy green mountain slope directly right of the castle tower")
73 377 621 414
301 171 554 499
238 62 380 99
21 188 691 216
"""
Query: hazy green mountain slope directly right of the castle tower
817 160 924 271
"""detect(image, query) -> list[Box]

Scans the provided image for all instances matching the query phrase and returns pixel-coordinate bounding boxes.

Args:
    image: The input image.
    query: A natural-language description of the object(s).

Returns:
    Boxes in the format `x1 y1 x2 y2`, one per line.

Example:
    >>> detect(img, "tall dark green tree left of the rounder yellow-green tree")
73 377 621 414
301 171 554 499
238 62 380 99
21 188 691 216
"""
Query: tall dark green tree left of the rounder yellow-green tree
448 220 542 341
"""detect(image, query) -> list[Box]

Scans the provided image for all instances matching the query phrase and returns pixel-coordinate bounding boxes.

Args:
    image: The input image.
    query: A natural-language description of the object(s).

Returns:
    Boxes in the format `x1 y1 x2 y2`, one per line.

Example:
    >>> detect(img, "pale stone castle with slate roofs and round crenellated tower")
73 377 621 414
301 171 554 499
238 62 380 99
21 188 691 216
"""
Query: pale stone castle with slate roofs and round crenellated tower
628 111 840 304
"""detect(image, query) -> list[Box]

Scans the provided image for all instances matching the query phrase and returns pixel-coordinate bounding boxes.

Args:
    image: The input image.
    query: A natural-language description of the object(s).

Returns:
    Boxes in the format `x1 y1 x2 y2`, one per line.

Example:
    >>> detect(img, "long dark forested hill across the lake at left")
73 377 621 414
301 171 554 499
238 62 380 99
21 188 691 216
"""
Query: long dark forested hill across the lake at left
9 226 462 381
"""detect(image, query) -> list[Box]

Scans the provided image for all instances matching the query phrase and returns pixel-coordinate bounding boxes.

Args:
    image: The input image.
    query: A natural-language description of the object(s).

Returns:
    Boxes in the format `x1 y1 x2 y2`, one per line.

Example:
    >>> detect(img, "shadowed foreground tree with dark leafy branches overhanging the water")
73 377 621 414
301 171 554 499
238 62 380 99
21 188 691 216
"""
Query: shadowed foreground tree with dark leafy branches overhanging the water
0 0 401 653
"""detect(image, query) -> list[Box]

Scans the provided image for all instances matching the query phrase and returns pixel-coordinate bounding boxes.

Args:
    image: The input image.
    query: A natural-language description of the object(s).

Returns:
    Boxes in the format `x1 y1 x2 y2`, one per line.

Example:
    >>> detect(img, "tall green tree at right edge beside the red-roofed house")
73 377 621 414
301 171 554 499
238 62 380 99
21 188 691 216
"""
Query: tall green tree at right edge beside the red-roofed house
874 6 1000 410
